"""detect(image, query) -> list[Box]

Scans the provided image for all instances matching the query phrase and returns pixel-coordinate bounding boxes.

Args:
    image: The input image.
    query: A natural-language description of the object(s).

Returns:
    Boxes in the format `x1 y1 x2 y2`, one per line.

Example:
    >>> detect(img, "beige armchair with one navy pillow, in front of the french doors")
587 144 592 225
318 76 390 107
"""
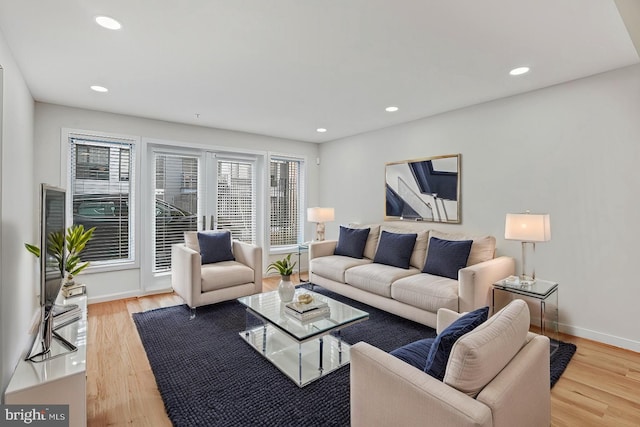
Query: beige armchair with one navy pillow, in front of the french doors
171 231 262 316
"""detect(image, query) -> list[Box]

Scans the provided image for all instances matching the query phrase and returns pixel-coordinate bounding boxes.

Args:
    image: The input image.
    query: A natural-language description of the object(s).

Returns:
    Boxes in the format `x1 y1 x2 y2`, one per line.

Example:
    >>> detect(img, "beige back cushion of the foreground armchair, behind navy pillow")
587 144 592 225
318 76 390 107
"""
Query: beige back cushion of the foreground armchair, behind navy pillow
444 299 530 397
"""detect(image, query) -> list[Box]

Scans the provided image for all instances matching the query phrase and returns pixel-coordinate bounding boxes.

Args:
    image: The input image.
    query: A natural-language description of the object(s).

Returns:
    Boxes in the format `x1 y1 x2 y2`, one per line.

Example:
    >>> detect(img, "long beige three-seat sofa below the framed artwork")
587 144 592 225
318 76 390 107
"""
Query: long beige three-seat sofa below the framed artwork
309 221 515 327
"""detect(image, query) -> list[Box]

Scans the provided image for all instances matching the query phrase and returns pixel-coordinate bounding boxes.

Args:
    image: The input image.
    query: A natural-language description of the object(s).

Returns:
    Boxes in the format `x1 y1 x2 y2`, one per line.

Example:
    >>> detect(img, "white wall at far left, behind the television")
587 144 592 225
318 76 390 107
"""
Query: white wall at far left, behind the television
0 34 39 396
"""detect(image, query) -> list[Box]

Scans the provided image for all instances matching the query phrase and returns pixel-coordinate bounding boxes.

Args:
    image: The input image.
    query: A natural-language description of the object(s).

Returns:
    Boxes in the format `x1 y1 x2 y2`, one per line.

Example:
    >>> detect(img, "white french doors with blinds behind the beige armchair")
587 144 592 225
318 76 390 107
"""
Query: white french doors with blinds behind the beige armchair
149 147 258 291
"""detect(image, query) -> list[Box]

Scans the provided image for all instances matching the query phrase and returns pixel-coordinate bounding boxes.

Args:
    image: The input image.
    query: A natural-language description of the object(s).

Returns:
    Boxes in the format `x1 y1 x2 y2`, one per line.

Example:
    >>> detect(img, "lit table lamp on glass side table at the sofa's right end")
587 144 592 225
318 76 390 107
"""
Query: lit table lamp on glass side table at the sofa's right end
504 211 551 286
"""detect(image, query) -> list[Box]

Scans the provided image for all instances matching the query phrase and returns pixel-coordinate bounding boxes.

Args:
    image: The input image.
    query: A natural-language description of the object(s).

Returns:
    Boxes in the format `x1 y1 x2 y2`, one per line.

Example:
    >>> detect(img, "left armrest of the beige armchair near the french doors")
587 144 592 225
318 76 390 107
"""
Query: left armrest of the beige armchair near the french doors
171 243 202 307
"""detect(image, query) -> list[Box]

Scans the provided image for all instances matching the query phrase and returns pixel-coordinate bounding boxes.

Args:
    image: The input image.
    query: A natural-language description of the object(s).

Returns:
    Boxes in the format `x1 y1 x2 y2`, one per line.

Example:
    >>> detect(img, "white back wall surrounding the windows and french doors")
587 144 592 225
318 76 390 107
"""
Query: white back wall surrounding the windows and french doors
34 102 319 302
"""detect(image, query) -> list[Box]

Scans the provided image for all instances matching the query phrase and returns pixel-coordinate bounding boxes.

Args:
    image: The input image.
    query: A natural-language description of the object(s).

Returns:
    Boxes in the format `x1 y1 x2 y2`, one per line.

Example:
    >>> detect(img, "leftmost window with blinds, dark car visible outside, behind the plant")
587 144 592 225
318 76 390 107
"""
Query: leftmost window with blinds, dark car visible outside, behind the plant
69 135 134 265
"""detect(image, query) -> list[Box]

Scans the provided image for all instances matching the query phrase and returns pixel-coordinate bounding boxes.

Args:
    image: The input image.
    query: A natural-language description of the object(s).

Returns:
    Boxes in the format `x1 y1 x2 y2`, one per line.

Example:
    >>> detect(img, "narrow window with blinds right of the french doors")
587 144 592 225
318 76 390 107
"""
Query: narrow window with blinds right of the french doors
269 157 304 247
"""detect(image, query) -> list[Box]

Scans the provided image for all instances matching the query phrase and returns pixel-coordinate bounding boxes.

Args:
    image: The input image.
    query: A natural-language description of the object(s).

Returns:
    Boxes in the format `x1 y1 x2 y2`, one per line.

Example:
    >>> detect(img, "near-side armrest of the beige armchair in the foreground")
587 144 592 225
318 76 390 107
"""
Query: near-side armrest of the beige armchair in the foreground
350 342 492 427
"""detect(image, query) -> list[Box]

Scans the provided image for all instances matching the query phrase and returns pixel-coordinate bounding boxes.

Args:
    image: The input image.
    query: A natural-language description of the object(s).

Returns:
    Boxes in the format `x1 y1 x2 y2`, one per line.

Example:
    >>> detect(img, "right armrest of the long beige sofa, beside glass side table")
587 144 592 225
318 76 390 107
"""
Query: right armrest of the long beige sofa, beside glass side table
458 256 516 312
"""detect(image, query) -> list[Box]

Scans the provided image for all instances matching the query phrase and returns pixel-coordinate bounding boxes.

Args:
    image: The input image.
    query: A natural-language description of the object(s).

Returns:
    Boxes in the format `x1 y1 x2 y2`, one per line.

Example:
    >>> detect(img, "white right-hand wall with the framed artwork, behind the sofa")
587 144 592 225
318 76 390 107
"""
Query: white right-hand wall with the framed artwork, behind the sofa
320 65 640 351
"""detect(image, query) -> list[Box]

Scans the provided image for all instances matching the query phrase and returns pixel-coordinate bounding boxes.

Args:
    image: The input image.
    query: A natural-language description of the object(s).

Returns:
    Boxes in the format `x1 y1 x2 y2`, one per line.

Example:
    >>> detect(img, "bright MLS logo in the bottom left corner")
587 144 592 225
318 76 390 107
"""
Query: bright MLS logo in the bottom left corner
0 405 69 427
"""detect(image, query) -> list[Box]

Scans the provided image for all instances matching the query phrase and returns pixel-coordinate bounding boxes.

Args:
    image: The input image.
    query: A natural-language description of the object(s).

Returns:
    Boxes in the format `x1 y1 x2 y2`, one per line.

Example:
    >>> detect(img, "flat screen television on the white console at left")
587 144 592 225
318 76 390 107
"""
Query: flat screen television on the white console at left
29 184 75 361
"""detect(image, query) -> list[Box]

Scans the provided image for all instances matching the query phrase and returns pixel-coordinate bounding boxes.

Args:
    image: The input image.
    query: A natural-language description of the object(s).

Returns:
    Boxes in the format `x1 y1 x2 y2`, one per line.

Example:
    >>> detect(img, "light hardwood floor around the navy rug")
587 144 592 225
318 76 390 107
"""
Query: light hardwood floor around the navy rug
87 278 640 427
